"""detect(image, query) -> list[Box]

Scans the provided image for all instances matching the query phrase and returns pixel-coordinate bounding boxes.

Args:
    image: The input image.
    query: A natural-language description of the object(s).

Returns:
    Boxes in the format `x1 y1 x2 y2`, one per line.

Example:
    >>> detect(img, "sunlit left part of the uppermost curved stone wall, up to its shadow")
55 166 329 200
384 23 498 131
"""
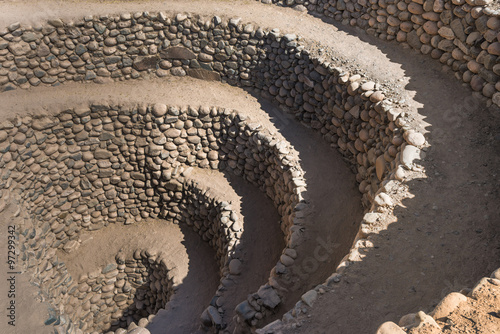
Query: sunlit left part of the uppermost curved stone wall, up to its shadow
0 12 265 90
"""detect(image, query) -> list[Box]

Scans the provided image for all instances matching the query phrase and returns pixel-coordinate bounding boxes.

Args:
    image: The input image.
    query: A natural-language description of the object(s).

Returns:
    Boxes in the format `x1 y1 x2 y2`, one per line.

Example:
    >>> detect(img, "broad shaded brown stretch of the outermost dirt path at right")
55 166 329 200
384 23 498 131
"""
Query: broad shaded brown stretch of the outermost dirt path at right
287 17 500 334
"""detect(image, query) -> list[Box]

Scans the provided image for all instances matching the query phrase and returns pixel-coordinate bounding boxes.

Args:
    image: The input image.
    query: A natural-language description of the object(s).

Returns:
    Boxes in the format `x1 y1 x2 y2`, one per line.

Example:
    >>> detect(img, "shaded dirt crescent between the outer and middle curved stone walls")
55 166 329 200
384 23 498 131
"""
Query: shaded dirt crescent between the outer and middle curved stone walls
262 100 363 316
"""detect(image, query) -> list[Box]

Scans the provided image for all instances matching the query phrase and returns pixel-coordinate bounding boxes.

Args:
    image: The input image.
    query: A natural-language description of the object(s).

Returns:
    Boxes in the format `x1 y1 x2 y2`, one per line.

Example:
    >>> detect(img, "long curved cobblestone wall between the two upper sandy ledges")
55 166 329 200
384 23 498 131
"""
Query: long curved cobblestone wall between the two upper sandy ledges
0 13 408 210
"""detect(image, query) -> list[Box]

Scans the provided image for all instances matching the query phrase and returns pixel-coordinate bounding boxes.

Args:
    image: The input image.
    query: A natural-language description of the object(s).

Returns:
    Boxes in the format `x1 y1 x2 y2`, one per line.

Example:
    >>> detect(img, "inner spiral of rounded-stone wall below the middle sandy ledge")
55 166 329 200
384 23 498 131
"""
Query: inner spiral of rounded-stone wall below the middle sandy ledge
0 104 305 330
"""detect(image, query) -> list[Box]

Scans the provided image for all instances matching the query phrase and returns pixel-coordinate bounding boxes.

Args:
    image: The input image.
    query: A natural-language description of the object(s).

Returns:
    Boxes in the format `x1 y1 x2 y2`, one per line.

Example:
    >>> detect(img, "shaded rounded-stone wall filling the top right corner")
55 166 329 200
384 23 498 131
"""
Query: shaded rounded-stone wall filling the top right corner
262 0 500 106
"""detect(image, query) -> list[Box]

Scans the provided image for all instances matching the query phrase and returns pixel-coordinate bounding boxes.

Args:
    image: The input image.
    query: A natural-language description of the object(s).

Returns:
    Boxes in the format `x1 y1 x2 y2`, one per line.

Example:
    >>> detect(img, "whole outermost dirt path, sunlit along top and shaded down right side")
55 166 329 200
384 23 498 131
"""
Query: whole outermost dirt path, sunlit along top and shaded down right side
0 1 500 333
